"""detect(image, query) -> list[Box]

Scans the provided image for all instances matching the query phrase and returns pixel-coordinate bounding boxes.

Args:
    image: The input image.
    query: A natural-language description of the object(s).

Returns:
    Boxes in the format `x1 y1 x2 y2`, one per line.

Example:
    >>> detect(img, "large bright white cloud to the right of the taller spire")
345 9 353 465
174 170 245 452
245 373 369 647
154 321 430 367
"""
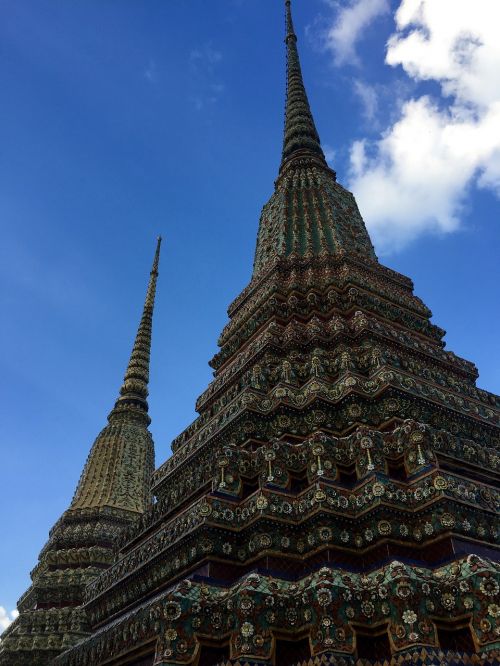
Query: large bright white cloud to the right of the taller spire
349 0 500 252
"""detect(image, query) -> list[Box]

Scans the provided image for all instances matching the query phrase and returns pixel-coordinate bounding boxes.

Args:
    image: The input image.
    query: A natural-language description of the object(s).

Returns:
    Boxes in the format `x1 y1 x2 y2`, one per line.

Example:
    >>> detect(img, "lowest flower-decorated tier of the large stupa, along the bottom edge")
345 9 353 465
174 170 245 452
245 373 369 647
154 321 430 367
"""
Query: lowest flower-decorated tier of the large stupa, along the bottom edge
57 555 500 666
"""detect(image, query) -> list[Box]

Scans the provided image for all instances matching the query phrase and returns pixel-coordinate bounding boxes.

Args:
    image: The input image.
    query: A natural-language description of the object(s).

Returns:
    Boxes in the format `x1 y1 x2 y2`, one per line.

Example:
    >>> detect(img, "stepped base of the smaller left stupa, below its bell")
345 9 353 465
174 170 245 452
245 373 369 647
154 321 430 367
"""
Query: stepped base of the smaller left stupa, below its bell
0 508 131 666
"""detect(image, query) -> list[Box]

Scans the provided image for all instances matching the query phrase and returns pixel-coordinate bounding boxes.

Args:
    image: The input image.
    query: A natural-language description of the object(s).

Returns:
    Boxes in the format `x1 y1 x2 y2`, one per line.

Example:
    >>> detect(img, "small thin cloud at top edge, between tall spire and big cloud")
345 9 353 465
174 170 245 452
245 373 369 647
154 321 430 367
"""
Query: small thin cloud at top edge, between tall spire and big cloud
325 0 389 65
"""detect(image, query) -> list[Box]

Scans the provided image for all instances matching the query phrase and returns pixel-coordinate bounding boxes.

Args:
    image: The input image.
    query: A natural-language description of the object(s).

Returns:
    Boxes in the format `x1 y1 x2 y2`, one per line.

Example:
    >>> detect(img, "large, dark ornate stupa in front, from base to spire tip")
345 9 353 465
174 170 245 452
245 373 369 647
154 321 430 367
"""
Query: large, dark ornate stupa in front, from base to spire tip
1 0 500 666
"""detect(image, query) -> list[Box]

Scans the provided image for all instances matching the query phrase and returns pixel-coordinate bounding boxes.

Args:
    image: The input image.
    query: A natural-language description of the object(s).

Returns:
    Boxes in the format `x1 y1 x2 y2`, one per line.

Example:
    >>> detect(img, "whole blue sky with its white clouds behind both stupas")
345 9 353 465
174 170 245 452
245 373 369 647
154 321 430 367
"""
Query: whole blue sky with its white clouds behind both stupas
0 0 500 626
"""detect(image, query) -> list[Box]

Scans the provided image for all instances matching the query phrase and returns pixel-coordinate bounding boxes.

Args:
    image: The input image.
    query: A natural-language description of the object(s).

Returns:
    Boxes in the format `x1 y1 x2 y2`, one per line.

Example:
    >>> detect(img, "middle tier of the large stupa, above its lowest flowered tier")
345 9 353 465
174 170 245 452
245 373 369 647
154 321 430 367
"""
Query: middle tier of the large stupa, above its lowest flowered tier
77 422 500 624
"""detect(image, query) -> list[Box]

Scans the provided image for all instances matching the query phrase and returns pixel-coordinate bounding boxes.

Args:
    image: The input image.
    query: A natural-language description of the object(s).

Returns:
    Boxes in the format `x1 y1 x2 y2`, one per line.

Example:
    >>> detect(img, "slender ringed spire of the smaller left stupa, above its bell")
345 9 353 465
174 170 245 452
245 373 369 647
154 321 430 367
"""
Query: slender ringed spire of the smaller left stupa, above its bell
109 236 162 420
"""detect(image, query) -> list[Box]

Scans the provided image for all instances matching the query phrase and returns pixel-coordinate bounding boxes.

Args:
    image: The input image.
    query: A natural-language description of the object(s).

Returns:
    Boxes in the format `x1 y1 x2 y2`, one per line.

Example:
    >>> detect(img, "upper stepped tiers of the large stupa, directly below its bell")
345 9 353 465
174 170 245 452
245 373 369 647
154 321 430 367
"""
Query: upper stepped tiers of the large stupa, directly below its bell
153 257 500 504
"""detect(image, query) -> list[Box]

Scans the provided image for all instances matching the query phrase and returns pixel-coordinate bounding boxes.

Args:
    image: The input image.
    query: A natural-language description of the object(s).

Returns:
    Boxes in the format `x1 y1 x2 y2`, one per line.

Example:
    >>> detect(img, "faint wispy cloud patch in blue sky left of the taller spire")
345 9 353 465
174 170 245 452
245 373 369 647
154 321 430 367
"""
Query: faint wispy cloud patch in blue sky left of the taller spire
189 43 225 111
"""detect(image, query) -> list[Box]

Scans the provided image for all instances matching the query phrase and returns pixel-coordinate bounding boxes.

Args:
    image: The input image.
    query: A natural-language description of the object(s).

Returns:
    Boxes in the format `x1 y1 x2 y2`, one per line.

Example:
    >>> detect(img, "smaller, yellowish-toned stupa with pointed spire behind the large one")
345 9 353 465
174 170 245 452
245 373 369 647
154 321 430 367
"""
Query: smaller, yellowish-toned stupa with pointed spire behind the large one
0 238 161 666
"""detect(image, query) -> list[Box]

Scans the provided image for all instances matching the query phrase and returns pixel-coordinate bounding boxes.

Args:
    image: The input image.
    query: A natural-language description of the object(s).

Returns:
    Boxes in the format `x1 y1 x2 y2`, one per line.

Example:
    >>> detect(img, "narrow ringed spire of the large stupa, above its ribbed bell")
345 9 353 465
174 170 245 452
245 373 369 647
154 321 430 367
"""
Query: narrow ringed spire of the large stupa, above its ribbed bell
280 0 326 171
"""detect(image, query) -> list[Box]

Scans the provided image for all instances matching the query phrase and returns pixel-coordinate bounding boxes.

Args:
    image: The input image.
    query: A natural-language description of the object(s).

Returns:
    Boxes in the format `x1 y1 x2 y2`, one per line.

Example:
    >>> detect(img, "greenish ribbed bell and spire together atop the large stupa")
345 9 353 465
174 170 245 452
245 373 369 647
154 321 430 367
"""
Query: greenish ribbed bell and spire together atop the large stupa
253 0 377 277
